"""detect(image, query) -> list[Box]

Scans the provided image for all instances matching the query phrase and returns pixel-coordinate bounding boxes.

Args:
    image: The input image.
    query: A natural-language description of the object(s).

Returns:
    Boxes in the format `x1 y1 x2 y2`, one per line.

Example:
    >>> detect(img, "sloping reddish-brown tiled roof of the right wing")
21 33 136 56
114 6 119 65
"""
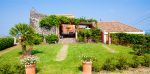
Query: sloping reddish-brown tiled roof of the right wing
98 21 143 32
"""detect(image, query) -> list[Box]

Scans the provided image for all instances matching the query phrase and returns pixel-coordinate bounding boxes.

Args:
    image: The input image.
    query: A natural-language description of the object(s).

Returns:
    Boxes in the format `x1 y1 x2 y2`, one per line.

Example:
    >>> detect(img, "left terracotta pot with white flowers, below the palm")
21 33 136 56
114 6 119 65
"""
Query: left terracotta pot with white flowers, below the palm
21 55 38 74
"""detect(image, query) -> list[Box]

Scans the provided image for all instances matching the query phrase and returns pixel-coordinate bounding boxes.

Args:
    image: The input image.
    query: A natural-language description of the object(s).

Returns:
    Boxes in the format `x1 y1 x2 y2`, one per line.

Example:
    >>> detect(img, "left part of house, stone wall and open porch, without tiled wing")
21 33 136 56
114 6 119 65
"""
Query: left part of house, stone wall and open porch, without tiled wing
30 9 96 39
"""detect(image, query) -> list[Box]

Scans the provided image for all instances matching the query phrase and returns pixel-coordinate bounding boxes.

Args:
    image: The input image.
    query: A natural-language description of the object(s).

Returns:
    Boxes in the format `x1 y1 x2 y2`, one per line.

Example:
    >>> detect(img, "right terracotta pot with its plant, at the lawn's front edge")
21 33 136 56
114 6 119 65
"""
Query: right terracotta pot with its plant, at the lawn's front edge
82 56 93 74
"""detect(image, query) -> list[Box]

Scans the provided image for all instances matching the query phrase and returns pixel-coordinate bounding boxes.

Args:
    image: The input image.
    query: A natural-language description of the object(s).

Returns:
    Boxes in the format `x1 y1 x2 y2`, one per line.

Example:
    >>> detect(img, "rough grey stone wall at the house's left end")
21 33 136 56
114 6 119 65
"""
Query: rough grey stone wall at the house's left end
30 9 56 35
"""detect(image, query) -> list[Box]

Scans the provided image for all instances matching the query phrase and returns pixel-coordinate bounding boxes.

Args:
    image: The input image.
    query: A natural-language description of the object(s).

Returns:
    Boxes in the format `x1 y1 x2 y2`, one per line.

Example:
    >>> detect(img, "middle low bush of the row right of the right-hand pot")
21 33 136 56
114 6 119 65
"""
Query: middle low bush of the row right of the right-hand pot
116 56 129 70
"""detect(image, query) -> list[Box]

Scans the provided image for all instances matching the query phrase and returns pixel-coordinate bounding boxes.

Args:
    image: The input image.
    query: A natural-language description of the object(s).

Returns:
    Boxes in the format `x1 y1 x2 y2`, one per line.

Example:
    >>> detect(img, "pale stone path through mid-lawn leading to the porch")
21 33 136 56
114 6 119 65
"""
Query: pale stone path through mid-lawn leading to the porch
56 44 68 61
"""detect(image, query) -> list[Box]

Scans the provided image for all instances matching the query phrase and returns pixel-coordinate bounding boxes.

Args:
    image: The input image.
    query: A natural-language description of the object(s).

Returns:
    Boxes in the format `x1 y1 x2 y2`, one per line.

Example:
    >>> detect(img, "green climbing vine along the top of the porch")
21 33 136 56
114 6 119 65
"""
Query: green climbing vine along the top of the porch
40 15 97 28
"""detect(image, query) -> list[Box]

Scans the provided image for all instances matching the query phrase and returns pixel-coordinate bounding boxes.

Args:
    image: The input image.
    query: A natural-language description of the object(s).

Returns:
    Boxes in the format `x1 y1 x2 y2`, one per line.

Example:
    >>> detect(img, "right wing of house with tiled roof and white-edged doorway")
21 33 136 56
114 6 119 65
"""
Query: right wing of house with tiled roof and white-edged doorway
98 21 145 44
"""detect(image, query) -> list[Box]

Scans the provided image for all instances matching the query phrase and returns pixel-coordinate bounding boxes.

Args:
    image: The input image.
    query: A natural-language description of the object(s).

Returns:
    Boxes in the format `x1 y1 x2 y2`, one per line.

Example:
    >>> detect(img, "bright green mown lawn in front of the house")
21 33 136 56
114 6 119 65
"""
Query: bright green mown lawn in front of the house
0 43 132 74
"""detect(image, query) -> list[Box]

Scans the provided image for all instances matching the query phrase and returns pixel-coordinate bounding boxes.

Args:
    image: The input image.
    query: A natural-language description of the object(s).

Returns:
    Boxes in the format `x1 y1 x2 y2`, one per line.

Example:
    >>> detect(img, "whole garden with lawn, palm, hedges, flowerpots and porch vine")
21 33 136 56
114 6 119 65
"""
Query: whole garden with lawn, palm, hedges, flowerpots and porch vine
0 15 150 74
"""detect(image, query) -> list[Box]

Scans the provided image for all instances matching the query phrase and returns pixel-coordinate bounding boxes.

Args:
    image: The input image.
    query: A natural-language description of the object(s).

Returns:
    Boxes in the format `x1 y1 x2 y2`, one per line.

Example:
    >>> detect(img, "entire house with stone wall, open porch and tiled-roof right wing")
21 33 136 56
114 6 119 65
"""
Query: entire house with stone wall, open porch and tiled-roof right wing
30 9 145 44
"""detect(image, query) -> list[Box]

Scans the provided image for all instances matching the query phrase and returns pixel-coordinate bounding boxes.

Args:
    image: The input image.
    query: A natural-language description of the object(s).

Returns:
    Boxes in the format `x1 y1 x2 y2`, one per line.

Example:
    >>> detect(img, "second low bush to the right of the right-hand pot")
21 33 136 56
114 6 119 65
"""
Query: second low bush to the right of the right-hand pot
102 58 116 71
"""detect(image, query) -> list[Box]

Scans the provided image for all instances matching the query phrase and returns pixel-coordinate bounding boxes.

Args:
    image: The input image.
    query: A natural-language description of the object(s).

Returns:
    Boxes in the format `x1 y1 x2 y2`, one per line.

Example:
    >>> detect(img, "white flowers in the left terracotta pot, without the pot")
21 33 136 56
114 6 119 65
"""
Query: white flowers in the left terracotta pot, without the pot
21 55 38 65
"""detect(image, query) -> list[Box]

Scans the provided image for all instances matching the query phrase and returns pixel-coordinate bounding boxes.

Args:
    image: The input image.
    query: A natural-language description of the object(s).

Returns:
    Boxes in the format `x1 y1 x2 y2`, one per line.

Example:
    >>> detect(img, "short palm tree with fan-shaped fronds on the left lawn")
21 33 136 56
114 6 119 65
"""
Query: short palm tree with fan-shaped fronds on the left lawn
9 23 34 55
